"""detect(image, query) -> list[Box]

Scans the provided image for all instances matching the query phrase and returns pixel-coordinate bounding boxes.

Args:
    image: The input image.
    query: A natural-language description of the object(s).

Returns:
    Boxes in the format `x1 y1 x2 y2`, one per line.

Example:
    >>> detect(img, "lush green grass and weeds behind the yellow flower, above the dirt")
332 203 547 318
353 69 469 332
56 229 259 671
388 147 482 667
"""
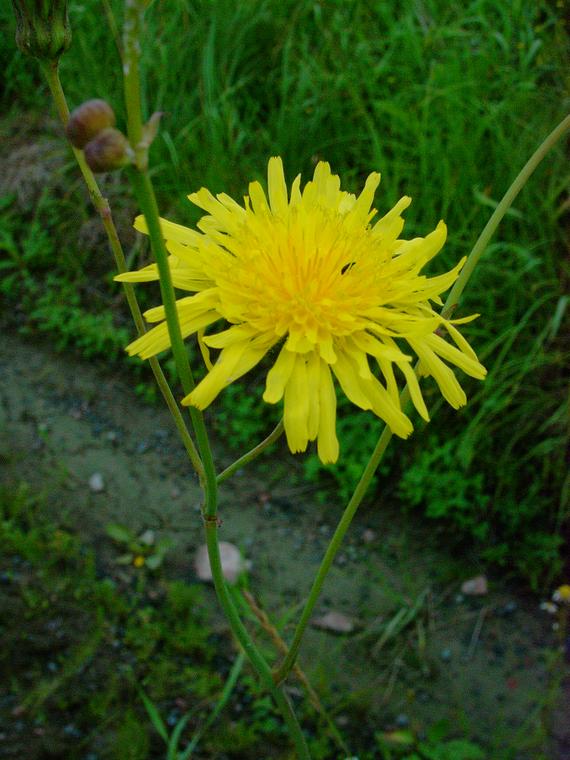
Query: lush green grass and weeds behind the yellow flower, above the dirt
0 0 569 586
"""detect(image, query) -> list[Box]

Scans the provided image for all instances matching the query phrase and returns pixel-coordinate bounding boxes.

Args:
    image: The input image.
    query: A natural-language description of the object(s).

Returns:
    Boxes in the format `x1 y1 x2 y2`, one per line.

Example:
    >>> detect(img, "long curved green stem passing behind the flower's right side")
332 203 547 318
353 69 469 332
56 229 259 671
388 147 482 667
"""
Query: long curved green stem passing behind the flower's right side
273 108 570 684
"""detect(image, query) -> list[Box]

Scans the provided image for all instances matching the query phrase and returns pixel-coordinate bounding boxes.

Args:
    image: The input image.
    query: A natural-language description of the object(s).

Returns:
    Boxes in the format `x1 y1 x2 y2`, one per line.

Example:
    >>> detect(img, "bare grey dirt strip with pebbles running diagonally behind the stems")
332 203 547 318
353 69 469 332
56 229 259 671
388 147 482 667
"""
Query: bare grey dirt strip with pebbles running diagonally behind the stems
0 335 570 760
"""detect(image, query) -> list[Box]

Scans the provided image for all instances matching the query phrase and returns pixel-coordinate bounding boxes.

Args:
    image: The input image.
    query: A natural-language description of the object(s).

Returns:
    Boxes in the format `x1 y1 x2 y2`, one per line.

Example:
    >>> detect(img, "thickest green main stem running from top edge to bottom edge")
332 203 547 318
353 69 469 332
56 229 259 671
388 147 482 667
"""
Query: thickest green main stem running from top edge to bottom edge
119 0 310 760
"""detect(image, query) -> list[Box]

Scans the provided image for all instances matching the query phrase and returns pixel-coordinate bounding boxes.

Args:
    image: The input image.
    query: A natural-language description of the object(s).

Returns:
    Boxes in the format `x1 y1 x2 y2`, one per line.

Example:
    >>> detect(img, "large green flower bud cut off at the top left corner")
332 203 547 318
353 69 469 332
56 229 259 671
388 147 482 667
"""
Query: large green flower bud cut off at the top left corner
12 0 71 62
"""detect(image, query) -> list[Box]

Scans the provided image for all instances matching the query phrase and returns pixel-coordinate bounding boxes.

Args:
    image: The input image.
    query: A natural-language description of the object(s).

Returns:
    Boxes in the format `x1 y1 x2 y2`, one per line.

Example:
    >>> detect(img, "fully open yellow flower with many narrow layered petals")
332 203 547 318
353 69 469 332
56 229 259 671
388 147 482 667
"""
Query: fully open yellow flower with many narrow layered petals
116 158 485 463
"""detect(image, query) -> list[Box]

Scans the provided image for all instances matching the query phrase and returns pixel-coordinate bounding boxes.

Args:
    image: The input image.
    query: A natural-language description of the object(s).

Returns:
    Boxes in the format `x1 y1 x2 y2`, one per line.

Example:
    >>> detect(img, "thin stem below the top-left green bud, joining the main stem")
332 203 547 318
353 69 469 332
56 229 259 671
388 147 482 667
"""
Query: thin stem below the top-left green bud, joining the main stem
42 62 204 477
